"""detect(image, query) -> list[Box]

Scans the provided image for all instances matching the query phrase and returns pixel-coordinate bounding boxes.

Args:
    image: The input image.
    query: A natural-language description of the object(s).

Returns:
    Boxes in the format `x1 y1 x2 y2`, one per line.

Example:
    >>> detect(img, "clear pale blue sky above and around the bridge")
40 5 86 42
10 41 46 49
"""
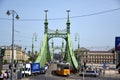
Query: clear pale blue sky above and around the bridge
0 0 120 51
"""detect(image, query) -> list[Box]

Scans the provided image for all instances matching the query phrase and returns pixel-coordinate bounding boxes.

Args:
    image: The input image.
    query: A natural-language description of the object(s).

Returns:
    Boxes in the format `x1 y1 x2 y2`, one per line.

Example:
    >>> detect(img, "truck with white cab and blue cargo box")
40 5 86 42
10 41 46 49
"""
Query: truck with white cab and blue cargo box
21 63 40 77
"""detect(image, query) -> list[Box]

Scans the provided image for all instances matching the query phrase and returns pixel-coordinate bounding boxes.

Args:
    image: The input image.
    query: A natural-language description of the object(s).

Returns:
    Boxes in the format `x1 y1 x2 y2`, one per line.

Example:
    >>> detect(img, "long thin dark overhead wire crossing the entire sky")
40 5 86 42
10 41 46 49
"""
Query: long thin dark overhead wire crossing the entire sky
0 8 120 21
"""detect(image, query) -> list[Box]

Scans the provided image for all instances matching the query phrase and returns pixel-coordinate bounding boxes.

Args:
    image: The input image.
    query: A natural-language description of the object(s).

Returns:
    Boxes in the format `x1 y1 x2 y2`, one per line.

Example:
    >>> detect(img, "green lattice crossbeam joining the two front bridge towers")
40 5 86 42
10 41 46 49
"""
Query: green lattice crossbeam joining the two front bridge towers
47 29 67 40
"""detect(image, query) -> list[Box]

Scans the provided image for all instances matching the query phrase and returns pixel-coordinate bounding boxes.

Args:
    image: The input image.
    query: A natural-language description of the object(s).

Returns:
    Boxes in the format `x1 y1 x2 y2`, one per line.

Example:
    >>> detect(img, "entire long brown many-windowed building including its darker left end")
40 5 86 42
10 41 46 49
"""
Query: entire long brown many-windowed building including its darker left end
75 48 116 64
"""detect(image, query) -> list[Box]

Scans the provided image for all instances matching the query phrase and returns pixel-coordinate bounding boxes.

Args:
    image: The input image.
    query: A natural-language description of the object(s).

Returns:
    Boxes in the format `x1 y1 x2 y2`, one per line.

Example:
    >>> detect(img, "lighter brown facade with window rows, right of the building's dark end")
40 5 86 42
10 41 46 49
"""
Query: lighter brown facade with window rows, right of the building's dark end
87 51 116 64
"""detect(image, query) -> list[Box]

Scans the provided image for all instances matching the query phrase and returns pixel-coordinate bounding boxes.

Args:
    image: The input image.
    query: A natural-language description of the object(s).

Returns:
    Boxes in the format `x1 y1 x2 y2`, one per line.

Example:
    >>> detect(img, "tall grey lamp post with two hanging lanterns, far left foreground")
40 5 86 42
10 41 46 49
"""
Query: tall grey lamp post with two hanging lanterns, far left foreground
6 10 19 80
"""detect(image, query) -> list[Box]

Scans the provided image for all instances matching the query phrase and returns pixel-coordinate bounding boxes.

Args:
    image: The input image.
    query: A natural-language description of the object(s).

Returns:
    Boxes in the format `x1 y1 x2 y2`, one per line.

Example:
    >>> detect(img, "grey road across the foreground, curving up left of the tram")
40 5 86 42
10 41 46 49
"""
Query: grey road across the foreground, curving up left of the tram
22 64 120 80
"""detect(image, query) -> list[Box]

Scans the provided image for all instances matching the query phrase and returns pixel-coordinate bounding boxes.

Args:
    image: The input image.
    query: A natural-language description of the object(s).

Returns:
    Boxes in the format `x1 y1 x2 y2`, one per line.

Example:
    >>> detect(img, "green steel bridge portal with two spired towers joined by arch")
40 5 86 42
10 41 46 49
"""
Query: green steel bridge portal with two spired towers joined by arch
35 10 78 70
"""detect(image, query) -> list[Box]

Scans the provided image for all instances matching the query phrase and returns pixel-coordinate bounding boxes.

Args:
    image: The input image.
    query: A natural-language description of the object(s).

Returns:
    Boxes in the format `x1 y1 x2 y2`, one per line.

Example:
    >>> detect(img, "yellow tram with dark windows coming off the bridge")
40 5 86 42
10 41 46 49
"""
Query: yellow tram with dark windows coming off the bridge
56 62 70 76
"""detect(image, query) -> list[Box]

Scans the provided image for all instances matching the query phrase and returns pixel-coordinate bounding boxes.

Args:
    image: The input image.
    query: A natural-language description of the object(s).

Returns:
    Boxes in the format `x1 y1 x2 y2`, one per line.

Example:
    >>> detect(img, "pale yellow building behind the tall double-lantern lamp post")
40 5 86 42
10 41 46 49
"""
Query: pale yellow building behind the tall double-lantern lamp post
2 45 29 63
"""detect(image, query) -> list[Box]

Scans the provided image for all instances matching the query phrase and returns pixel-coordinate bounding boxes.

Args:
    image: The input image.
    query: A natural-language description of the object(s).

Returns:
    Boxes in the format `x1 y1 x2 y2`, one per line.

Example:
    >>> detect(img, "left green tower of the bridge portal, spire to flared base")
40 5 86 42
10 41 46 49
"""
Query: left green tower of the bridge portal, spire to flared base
35 10 51 66
